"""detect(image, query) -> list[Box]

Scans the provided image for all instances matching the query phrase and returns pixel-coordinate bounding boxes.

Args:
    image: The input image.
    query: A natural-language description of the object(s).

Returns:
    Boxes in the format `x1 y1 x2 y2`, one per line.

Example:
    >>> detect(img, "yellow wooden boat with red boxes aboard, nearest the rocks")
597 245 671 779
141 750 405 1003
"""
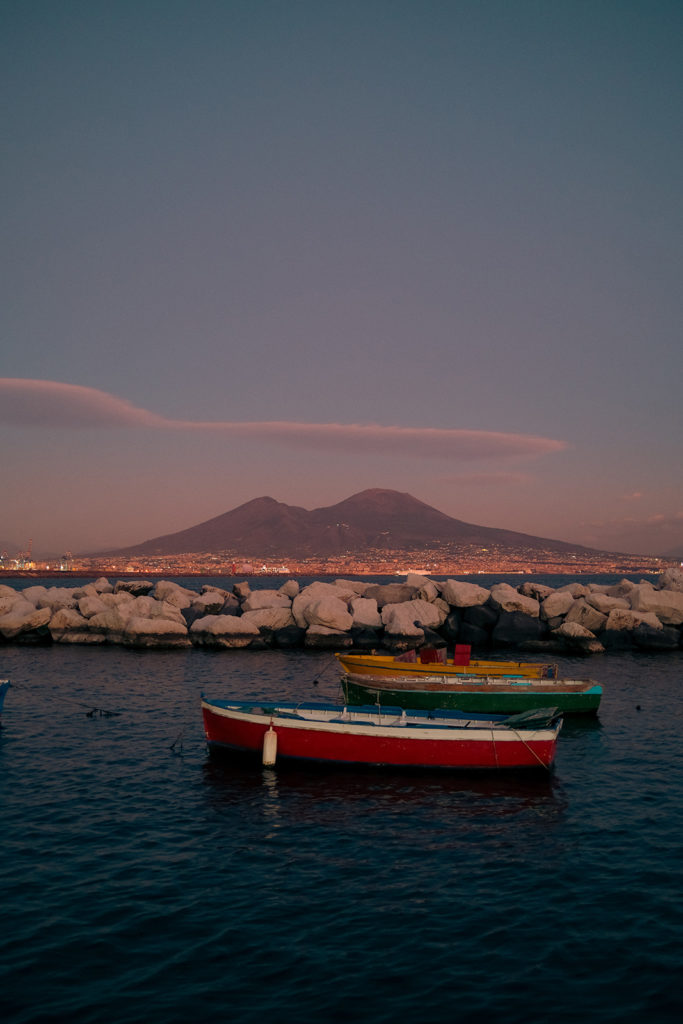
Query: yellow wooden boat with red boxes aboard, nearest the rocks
335 645 557 679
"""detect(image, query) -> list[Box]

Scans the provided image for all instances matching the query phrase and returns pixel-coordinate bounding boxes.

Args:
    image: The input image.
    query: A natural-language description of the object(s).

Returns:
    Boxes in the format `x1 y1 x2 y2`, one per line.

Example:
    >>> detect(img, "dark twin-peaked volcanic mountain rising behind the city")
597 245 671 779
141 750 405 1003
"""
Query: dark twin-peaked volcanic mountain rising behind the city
100 488 602 558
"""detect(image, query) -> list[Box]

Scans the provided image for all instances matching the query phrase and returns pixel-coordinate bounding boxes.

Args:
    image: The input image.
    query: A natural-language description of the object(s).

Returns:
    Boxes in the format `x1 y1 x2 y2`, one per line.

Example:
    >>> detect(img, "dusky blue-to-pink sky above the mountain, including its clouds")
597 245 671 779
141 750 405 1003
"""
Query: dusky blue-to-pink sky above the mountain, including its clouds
0 0 683 555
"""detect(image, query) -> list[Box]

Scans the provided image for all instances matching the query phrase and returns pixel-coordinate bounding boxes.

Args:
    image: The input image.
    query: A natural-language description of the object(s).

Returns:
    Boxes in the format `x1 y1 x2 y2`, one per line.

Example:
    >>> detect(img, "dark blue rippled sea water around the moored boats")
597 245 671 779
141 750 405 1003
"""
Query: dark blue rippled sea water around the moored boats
0 575 683 1024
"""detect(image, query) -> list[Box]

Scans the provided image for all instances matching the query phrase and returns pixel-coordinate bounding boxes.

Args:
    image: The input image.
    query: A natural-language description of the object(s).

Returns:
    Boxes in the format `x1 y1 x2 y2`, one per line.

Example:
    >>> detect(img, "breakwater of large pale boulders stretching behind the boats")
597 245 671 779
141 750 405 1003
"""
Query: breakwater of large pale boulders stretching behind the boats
0 568 683 655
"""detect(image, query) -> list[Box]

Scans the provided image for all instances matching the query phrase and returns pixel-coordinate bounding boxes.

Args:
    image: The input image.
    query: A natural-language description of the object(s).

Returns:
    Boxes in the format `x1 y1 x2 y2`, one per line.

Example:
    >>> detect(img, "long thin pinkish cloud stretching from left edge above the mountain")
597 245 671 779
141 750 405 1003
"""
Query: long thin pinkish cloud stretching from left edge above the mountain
0 378 567 461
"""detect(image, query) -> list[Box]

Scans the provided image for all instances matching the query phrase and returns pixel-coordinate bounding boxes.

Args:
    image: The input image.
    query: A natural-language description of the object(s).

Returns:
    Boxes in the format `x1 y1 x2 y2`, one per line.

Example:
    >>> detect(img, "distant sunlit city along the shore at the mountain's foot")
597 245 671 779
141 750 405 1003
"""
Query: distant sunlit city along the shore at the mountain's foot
0 544 678 578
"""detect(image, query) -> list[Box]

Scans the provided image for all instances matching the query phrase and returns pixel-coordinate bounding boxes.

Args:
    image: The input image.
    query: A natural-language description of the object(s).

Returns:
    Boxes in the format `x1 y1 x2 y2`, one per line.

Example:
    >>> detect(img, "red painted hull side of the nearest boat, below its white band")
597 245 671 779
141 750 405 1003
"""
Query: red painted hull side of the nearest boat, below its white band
203 708 556 768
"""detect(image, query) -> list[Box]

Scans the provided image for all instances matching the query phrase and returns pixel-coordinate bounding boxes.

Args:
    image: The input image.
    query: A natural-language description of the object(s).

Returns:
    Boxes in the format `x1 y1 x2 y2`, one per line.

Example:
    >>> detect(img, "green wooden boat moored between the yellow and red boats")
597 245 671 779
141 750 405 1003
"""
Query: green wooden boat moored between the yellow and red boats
341 674 602 715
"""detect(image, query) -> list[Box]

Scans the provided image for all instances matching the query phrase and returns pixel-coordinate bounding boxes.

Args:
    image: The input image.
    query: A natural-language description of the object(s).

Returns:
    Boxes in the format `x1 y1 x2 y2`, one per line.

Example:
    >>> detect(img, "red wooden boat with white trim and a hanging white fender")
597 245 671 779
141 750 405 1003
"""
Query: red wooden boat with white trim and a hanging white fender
202 697 562 769
